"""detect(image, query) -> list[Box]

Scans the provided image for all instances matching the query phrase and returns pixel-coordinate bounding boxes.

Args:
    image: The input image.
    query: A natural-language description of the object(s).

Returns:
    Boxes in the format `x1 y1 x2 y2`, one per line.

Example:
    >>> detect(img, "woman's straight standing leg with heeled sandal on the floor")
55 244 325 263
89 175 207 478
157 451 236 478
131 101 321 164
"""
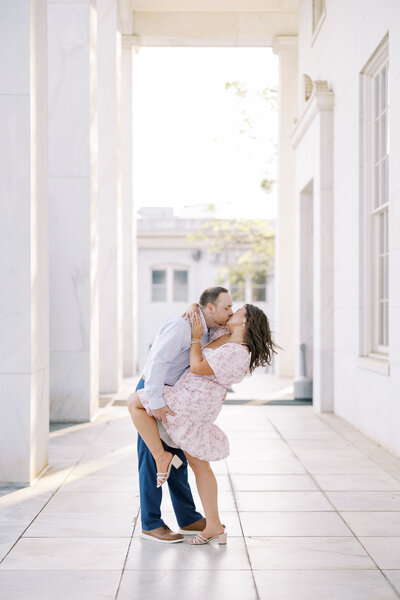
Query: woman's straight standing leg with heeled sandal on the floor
185 452 224 538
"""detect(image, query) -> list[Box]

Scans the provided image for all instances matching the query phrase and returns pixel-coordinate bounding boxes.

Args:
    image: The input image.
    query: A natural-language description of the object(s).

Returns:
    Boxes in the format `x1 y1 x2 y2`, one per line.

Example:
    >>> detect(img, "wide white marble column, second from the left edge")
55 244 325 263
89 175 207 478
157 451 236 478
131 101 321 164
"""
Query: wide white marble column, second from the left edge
48 0 98 421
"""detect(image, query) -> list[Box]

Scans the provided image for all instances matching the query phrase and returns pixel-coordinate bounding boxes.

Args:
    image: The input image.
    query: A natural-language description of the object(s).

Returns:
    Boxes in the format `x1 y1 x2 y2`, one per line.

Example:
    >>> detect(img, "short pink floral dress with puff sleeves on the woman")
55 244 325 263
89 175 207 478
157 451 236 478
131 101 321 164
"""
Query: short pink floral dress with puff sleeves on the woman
138 327 250 461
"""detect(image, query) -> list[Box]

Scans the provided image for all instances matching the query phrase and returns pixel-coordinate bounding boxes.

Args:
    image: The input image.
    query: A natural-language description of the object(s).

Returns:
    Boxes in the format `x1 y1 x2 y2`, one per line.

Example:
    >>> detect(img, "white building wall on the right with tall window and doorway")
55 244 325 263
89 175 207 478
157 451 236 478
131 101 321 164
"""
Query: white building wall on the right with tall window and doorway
291 0 400 454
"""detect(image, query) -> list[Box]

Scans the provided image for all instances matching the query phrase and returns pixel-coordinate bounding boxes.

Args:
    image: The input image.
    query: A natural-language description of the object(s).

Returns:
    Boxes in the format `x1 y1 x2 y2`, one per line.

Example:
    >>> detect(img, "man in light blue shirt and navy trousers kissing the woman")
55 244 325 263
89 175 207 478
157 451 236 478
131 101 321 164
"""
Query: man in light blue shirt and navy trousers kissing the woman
136 287 233 543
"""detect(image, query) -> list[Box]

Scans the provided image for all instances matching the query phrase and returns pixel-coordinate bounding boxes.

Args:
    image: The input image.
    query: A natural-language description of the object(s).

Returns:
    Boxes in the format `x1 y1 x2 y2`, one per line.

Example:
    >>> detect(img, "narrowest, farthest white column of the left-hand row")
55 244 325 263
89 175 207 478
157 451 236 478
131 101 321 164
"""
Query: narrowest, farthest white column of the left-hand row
121 35 136 377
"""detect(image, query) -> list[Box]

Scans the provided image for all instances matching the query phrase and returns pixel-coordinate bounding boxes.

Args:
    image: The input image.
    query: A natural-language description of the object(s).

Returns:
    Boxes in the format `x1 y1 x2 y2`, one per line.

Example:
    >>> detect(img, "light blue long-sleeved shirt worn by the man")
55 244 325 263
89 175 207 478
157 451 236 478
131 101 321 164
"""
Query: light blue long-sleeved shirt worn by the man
143 310 209 410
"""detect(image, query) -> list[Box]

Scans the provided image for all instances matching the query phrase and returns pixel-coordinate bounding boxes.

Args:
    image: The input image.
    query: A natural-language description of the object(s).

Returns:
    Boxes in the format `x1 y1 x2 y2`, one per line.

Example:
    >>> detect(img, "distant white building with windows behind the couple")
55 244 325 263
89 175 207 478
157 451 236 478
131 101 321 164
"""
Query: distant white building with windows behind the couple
137 208 276 373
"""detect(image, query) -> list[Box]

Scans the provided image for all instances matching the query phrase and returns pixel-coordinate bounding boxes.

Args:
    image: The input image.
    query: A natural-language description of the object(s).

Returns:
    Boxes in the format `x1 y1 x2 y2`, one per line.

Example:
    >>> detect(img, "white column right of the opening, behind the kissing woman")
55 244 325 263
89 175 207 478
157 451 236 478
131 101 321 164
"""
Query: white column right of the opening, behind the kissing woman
274 36 298 377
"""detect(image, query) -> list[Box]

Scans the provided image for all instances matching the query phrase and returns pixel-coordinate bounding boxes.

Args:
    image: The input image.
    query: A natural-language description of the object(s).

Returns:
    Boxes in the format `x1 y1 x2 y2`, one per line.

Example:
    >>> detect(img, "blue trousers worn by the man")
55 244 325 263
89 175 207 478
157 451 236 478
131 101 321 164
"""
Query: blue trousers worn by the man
136 379 202 531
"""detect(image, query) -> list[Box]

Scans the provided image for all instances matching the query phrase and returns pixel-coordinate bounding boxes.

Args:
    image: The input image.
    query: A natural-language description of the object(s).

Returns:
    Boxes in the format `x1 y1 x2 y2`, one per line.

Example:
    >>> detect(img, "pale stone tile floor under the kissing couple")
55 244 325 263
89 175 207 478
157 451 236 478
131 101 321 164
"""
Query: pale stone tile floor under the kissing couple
0 378 400 600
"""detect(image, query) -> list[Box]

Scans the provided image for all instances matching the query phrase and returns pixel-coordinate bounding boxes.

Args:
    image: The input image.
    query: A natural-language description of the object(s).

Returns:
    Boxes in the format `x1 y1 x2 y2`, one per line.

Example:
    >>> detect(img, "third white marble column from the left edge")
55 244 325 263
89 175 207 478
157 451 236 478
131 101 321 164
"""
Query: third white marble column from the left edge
97 0 123 393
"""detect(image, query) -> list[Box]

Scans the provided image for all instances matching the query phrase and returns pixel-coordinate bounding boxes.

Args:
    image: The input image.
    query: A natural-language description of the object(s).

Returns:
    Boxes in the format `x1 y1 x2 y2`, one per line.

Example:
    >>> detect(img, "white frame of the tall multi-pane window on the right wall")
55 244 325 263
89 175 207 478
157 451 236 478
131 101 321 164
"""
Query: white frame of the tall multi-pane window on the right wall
359 36 389 375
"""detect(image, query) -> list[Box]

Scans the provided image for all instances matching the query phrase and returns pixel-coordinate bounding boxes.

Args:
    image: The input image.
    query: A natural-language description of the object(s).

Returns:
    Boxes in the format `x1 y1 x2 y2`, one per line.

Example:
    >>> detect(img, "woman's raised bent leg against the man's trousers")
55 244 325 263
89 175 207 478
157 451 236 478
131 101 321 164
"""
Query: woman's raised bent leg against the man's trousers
128 392 172 473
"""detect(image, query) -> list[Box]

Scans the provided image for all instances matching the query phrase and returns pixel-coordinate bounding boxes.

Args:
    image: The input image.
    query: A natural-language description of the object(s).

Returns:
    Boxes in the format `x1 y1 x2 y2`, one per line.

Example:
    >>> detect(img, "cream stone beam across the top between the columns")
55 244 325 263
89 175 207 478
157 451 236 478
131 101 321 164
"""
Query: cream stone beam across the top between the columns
120 0 298 46
